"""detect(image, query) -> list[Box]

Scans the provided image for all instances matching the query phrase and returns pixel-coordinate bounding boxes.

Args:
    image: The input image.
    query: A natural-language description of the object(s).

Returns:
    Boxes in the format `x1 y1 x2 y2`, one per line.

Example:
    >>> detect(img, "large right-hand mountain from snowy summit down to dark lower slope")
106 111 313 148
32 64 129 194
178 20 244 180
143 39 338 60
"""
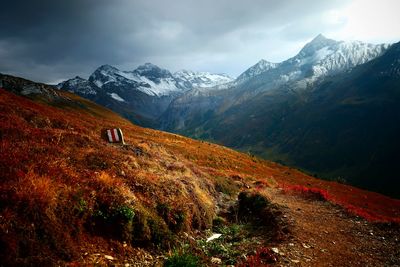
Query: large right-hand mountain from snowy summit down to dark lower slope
162 36 400 198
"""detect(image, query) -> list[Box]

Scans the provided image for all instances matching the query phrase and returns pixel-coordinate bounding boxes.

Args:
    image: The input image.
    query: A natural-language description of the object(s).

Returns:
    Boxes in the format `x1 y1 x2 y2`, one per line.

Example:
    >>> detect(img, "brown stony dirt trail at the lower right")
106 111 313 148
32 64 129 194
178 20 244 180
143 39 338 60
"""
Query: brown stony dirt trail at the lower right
267 189 400 266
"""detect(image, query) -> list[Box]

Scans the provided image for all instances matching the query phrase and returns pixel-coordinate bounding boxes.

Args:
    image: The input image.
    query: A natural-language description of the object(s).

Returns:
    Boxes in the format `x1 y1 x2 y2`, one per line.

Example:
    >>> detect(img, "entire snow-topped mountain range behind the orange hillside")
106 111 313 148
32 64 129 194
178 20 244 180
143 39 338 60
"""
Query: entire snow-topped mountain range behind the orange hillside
23 35 400 197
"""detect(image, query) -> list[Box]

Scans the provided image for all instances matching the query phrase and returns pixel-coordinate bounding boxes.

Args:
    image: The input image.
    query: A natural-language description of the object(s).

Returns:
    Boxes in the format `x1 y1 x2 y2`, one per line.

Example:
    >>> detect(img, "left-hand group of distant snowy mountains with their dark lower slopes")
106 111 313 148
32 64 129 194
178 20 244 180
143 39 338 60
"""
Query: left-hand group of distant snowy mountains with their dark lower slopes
57 63 233 127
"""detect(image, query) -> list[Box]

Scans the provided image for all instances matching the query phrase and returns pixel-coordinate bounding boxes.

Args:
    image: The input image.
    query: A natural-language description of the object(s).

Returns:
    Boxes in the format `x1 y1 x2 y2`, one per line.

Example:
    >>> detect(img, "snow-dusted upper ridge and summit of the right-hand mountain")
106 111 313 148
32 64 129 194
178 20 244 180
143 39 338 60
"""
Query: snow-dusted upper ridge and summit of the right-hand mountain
225 34 390 97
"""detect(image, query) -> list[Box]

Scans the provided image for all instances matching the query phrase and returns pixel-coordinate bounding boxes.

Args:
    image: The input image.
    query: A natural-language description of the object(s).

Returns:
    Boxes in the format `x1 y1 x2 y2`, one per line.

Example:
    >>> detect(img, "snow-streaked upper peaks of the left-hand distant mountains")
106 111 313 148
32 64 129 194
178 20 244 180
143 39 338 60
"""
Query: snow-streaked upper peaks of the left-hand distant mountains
58 63 233 99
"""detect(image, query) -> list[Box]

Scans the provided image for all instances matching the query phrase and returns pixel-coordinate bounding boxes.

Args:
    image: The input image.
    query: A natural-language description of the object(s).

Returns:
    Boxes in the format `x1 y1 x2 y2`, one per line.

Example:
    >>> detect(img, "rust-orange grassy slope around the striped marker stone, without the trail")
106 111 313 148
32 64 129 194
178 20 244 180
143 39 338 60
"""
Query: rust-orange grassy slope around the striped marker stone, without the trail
0 89 400 265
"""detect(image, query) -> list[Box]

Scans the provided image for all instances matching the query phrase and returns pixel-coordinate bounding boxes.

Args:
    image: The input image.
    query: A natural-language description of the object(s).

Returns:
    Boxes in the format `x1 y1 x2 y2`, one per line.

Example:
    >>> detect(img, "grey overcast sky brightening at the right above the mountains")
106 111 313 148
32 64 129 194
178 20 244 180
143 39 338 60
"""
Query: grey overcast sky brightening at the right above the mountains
0 0 400 83
